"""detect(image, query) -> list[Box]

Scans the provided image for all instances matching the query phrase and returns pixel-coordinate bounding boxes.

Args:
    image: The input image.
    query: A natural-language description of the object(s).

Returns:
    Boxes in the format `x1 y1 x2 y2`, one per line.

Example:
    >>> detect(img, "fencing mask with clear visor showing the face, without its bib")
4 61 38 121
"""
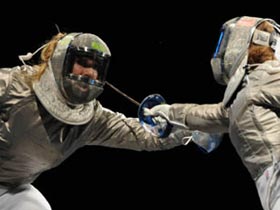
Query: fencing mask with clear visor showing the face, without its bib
51 33 111 105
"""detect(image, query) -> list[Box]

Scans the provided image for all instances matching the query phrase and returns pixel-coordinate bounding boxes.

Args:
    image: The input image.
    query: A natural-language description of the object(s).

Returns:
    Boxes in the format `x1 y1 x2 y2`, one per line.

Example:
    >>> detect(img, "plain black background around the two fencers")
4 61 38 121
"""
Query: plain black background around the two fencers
0 1 280 210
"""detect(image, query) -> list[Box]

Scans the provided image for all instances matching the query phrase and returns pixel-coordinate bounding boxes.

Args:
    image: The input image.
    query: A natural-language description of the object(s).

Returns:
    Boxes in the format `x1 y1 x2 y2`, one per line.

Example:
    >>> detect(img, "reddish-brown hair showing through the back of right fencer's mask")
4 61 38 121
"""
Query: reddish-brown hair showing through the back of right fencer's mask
248 21 276 64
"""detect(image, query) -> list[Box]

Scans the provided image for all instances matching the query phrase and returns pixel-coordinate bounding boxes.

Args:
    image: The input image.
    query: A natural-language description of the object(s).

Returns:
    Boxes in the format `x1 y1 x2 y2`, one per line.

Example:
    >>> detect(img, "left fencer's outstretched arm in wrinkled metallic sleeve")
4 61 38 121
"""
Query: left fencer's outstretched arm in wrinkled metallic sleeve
83 102 192 151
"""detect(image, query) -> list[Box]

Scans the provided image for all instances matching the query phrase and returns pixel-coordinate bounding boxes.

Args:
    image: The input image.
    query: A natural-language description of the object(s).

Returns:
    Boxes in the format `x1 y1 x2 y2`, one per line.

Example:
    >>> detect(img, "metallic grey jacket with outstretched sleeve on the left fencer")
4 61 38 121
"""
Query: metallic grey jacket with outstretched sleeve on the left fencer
0 67 190 186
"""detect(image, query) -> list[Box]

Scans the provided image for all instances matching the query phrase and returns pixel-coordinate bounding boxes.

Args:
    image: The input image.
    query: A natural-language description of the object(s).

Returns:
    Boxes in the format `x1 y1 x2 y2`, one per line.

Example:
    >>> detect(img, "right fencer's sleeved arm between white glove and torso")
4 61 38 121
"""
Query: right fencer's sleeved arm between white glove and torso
169 103 229 133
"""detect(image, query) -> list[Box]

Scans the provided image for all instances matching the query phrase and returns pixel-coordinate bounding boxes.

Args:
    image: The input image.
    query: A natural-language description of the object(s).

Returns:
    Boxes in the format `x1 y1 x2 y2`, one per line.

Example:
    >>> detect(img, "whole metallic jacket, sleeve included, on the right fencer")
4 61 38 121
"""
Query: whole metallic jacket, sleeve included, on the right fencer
169 60 280 180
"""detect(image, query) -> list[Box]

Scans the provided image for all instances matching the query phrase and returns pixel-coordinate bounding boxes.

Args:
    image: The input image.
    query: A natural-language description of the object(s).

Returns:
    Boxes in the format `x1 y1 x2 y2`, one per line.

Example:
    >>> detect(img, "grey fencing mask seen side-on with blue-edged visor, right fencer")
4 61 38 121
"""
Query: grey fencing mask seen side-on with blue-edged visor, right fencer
211 16 279 85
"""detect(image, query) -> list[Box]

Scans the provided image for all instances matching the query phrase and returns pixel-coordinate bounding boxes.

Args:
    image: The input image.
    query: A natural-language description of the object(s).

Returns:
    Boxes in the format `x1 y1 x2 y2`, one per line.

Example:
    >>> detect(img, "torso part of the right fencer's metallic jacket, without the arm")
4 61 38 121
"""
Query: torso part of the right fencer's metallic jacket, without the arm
229 61 280 180
